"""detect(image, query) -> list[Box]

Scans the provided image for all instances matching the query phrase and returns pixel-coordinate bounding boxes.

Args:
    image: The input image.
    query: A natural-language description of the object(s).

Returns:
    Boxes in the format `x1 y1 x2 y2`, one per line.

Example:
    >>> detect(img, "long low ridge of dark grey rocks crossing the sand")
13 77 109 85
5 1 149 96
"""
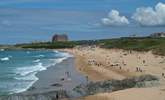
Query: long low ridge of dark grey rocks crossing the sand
74 75 158 96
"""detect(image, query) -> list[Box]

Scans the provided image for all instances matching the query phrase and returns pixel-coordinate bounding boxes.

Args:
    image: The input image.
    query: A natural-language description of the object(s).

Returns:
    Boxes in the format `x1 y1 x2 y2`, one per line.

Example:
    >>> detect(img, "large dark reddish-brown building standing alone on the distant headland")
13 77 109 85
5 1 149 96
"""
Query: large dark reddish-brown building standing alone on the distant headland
52 34 68 42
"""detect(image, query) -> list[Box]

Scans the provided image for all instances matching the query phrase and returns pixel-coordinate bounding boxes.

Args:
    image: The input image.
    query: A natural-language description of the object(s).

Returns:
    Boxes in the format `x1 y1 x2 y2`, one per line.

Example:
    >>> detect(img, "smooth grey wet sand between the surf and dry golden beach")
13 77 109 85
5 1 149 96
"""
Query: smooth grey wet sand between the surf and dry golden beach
23 57 86 97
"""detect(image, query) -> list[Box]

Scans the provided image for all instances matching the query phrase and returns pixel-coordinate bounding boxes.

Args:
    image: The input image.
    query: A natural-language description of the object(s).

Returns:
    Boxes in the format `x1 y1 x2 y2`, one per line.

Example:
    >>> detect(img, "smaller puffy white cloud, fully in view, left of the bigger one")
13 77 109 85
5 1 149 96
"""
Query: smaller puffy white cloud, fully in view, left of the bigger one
102 10 129 26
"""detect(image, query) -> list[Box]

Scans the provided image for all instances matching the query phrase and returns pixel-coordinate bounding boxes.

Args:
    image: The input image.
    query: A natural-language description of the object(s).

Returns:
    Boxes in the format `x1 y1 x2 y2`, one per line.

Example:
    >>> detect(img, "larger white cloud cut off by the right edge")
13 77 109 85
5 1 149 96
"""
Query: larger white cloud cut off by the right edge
132 3 165 26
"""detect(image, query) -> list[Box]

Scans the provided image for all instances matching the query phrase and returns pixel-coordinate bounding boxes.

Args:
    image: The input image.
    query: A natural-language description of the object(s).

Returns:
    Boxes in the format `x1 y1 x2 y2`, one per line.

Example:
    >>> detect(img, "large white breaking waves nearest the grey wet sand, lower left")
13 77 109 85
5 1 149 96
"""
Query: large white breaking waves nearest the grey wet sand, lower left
10 63 46 94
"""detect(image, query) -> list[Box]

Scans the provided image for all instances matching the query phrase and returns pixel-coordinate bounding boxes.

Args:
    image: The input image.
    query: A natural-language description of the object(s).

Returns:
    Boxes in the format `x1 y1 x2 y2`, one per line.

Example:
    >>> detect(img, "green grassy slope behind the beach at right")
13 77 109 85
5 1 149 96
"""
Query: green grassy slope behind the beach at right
101 38 165 55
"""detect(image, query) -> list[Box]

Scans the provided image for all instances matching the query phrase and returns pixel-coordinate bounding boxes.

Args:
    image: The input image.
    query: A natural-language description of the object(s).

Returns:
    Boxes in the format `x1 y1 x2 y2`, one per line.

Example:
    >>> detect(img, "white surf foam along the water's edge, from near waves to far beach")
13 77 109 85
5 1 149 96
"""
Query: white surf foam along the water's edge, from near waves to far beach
12 51 73 93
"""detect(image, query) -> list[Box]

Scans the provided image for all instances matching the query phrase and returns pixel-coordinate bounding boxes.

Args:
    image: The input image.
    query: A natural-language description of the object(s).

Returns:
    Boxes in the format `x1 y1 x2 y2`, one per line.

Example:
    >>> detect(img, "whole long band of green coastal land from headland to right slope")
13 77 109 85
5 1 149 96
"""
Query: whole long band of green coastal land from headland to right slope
15 37 165 55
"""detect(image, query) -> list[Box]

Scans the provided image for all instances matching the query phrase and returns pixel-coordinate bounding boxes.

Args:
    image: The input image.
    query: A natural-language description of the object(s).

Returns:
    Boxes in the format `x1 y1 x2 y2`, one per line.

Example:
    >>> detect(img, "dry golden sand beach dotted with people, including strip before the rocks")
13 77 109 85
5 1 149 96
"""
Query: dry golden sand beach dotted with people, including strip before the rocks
66 47 165 100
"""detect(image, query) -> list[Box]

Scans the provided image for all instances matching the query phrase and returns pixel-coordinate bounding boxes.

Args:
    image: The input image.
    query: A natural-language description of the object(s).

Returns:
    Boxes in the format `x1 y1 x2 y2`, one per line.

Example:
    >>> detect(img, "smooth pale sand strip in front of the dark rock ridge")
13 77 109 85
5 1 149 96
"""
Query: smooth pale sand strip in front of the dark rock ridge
82 87 165 100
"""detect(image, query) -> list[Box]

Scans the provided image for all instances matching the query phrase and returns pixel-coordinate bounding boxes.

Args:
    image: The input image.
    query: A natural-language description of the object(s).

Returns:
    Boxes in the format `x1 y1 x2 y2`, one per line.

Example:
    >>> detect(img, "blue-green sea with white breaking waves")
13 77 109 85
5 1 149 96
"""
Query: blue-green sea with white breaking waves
0 49 71 95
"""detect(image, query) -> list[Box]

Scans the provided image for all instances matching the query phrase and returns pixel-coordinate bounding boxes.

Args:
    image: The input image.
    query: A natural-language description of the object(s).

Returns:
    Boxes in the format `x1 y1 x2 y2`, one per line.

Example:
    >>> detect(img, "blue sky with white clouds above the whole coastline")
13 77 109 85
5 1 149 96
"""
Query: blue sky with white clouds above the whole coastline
0 0 165 44
